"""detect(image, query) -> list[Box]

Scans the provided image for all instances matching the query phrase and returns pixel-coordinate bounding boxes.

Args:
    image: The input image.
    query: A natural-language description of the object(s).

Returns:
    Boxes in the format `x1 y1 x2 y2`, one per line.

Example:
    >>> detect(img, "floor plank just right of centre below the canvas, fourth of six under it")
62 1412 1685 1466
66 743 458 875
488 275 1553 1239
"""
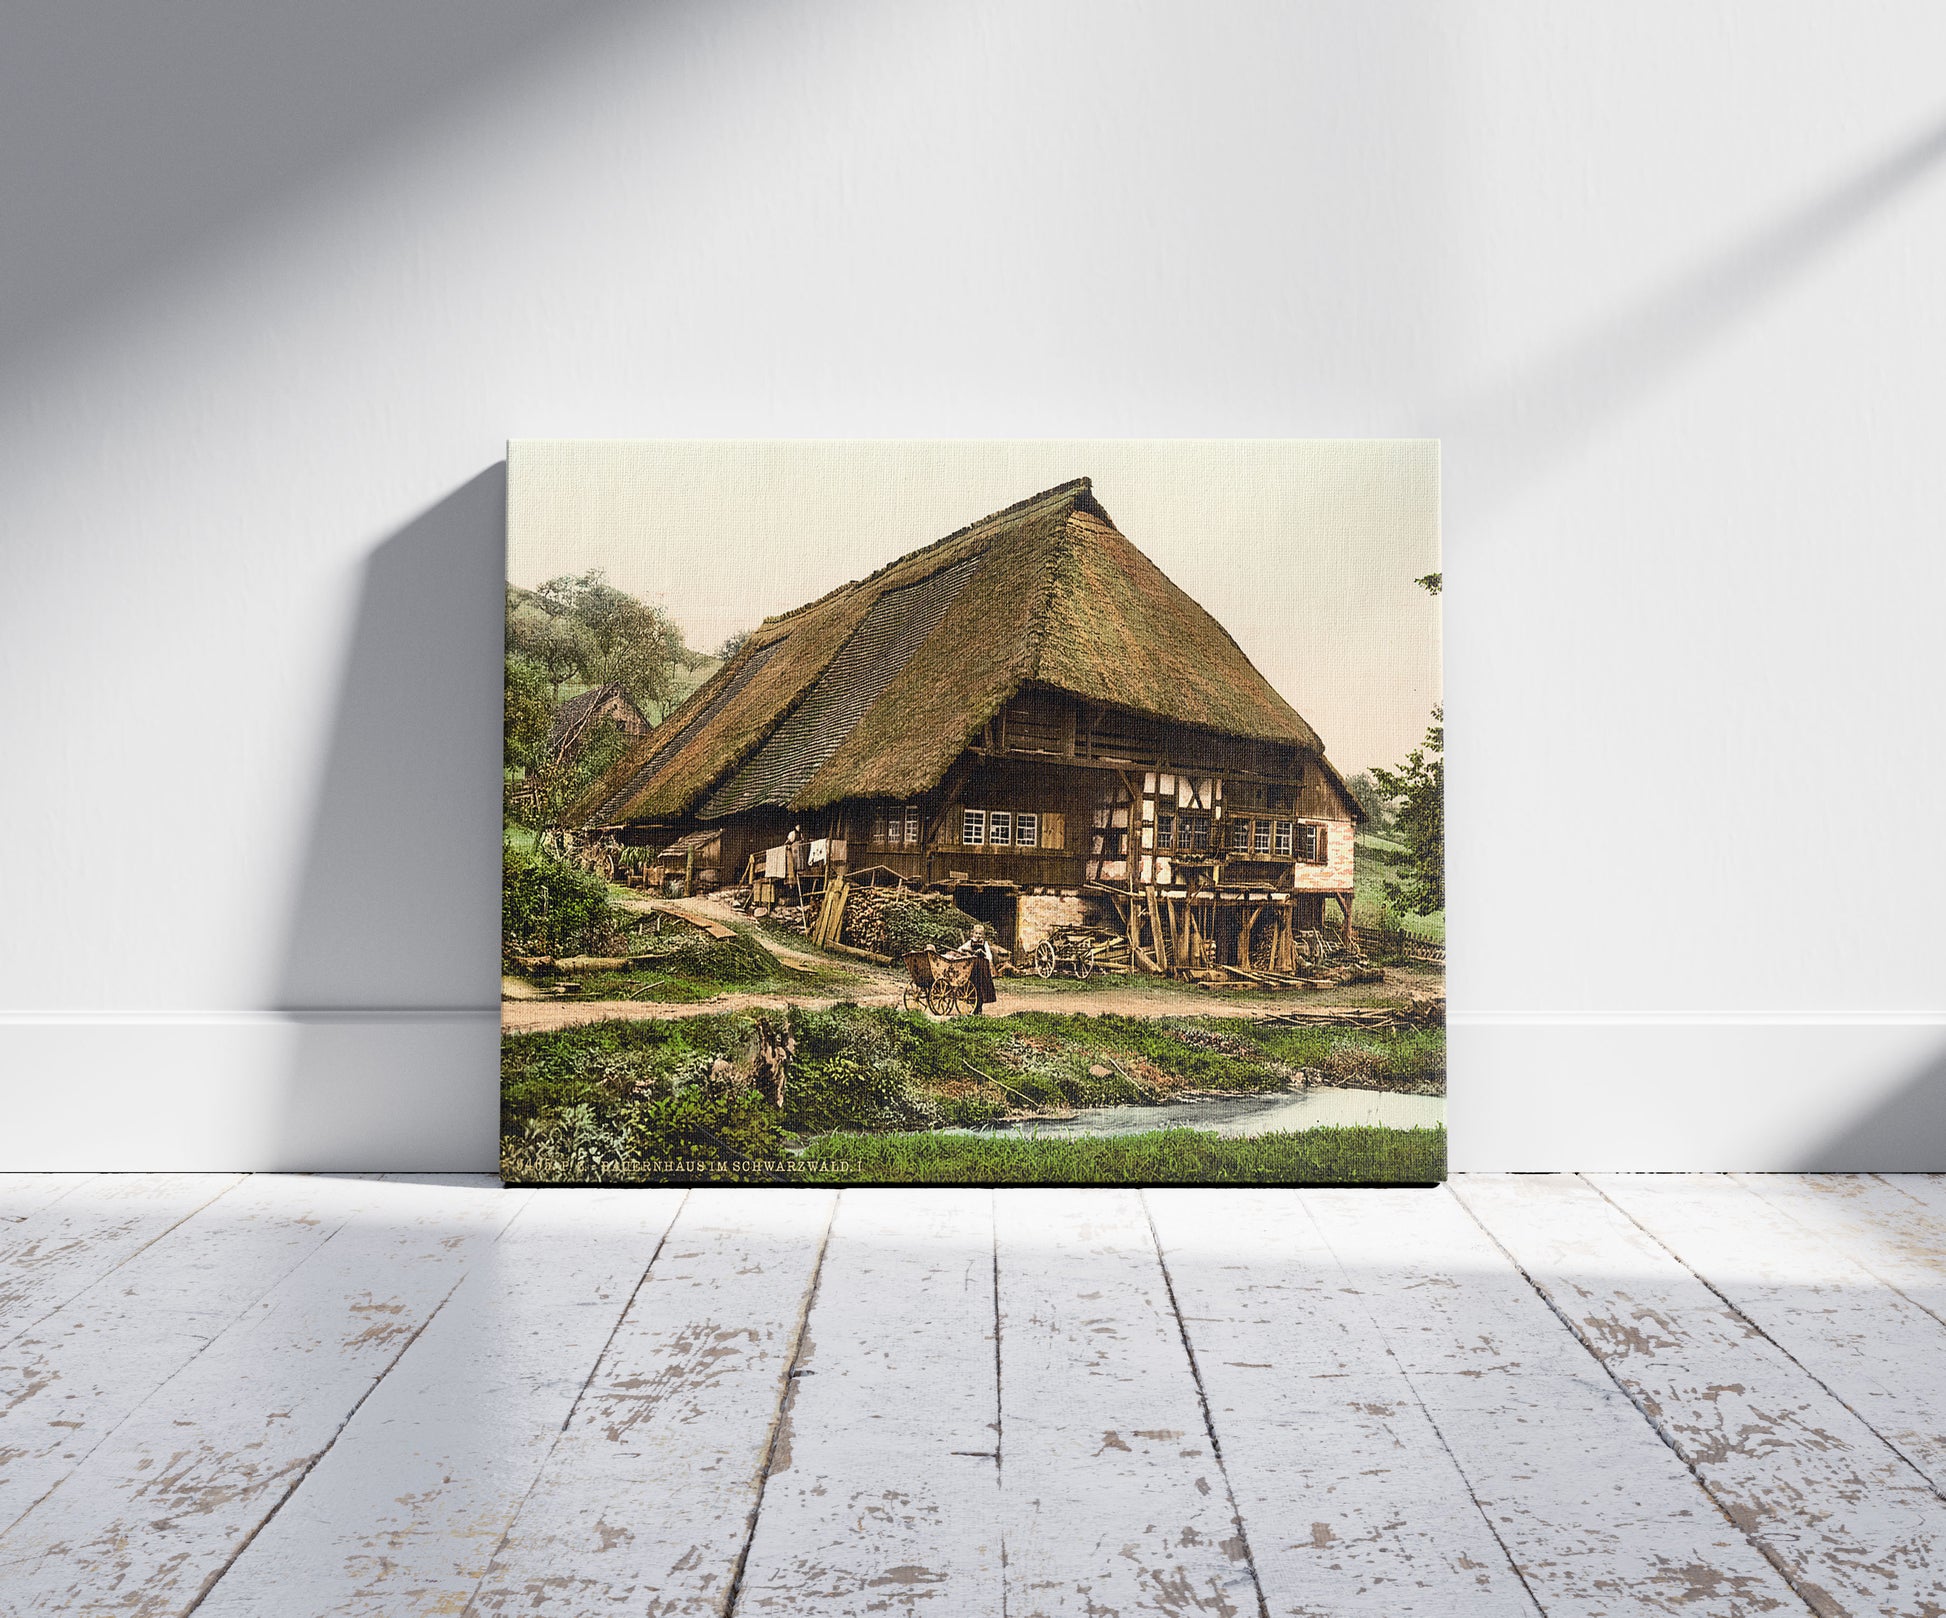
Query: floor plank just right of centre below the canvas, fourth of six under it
996 1190 1259 1618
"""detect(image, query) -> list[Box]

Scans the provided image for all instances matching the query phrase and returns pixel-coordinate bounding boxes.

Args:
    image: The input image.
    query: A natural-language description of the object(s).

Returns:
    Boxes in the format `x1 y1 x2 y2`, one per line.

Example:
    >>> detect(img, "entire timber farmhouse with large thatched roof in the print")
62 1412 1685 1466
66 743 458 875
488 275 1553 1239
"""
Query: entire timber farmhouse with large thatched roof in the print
574 477 1362 972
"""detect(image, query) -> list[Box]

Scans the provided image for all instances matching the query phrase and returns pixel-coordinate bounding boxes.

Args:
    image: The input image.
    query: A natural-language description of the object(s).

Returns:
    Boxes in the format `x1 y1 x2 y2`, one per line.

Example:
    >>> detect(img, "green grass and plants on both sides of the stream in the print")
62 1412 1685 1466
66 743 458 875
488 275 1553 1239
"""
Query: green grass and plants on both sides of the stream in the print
500 1005 1446 1184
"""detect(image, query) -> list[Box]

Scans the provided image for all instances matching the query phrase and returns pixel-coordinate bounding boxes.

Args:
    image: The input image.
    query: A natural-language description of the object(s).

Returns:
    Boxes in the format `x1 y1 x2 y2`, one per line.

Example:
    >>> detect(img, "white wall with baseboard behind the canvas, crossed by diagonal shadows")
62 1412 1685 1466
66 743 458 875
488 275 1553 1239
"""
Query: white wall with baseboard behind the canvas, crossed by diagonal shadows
0 0 1946 1168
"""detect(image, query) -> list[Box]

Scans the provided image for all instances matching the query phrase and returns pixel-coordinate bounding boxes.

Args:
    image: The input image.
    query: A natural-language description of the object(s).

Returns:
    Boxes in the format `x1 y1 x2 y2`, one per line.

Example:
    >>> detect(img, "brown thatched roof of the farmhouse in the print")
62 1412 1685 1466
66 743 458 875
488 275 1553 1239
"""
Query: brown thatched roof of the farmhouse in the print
574 477 1323 826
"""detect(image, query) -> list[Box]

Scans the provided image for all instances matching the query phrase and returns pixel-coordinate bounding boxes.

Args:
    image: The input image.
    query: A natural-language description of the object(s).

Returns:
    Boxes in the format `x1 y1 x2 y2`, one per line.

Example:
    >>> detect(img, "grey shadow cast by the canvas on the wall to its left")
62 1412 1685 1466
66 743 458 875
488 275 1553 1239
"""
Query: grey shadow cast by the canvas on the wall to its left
274 463 506 1170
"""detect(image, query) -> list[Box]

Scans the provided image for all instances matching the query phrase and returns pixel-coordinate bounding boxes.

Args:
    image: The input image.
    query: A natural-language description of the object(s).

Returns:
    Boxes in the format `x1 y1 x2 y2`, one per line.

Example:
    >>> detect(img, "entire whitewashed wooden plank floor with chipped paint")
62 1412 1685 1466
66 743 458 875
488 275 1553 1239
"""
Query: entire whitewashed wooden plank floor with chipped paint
0 1174 1946 1618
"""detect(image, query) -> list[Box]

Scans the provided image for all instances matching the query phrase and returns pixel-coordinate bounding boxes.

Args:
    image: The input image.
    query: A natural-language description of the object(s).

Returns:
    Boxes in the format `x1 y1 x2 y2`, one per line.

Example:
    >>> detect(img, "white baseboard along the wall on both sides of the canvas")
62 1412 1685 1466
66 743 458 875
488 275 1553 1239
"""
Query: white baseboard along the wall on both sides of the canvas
0 1009 1946 1172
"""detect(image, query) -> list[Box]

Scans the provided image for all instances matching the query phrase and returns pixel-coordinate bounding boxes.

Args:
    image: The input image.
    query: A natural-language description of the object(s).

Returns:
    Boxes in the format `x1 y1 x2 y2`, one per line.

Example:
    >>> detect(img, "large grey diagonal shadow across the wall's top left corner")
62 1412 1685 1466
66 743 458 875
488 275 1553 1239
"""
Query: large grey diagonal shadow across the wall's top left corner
0 0 638 364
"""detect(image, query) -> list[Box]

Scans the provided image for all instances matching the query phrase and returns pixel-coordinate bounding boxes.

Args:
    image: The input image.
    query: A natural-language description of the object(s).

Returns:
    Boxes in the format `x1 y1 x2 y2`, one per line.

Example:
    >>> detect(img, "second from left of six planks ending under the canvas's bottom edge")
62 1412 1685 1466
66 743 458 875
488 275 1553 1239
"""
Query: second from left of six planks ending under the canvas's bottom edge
467 1190 837 1618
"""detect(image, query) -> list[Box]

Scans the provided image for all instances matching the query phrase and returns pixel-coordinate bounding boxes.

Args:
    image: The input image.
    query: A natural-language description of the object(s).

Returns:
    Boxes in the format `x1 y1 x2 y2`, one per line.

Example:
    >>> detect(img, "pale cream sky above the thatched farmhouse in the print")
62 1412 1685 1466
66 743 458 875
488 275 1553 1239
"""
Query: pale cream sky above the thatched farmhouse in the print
508 438 1440 773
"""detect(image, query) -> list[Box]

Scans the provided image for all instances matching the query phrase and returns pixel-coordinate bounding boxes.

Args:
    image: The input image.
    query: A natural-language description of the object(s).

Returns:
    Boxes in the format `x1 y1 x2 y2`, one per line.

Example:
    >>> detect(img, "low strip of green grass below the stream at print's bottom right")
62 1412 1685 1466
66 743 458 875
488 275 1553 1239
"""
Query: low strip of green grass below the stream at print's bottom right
788 1125 1446 1186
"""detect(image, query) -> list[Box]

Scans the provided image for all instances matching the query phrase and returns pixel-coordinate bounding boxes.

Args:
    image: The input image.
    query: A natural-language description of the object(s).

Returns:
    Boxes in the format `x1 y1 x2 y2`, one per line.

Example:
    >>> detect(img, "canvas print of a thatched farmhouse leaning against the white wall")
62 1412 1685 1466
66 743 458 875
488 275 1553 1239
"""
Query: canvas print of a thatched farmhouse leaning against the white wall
500 440 1446 1186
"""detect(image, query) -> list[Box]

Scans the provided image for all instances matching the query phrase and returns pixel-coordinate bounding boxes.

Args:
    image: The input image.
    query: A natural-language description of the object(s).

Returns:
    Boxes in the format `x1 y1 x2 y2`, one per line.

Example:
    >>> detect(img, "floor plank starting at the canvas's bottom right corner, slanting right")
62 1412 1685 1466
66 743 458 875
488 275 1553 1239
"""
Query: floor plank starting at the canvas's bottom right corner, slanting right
1458 1176 1946 1618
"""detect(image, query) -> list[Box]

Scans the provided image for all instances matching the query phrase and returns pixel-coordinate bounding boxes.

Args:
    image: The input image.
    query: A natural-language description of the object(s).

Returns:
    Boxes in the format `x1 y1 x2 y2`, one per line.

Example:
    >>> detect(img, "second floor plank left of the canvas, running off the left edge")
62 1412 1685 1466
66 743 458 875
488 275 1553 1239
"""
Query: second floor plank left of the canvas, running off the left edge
0 1174 391 1532
